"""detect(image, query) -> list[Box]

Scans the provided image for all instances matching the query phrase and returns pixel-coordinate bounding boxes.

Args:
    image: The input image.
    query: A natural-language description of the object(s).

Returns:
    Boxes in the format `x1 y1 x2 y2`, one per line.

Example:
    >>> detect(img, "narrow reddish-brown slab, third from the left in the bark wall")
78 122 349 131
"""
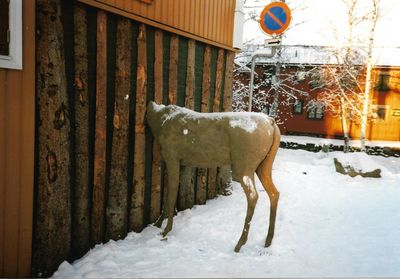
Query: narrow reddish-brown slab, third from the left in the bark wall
91 11 107 246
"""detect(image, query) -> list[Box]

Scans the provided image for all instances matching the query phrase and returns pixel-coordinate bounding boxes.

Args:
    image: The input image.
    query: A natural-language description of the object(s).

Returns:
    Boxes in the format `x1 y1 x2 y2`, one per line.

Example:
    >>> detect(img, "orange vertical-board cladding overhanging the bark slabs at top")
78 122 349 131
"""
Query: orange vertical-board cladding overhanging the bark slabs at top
80 0 236 48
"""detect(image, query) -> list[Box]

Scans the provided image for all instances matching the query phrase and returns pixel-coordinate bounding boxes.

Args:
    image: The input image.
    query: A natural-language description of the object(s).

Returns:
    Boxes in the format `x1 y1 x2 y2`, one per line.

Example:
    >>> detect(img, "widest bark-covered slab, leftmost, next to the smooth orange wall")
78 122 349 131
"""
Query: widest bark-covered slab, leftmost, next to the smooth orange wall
33 0 71 277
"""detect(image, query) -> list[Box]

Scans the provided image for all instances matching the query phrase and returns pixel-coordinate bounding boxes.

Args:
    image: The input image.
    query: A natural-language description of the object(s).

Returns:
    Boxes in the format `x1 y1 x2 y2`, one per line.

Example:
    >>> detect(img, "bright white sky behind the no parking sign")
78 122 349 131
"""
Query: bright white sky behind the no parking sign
243 0 400 47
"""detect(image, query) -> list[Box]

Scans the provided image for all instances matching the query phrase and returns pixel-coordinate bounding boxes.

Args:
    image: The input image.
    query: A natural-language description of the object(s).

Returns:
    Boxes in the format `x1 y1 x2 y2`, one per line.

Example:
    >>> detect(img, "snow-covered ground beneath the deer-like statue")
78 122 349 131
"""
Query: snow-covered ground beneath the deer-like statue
53 149 400 278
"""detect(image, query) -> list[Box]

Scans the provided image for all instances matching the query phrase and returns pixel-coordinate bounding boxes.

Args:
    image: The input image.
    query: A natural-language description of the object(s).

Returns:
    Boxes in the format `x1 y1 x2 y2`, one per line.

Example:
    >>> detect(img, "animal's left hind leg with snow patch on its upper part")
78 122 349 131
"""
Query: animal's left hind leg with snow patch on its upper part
235 173 258 252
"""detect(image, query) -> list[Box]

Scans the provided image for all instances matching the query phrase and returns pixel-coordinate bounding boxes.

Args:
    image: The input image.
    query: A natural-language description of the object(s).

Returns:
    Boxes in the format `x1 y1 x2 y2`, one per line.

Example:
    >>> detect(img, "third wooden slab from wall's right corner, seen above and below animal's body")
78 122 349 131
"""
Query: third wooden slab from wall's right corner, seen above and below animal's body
196 45 211 204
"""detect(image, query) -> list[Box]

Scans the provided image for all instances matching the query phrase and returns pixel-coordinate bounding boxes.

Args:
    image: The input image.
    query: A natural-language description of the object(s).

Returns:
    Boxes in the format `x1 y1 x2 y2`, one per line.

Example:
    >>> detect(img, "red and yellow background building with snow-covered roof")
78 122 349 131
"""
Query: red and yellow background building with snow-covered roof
237 46 400 141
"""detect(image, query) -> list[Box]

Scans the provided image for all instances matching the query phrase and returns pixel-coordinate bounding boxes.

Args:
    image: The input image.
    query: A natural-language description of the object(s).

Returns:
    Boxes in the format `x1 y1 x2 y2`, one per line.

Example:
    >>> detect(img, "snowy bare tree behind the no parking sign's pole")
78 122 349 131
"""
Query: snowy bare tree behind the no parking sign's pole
233 0 308 120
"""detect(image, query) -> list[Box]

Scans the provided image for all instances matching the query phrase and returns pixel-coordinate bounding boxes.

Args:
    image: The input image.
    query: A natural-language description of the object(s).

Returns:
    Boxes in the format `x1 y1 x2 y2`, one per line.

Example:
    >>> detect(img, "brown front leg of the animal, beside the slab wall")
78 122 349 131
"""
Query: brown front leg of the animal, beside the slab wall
162 160 179 236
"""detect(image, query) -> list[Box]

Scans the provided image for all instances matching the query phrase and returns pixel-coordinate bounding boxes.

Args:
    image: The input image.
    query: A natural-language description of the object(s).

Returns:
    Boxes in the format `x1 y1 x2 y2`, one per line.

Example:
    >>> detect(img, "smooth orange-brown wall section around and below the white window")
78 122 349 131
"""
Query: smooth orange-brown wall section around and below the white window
0 1 35 277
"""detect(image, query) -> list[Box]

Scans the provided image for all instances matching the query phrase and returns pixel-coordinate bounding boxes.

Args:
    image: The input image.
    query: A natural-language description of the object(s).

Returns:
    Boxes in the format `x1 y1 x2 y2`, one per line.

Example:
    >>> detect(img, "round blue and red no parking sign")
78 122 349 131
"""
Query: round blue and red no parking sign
260 2 292 35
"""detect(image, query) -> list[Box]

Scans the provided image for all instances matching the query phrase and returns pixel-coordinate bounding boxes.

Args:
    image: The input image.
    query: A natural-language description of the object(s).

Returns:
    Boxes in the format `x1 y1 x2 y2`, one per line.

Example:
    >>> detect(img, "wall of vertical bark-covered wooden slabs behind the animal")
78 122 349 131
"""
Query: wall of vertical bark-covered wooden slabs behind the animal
32 0 234 276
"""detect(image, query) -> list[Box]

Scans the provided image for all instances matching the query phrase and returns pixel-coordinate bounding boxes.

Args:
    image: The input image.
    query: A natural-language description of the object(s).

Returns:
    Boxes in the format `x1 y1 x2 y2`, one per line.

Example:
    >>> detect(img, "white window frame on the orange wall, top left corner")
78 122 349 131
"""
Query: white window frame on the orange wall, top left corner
0 0 23 70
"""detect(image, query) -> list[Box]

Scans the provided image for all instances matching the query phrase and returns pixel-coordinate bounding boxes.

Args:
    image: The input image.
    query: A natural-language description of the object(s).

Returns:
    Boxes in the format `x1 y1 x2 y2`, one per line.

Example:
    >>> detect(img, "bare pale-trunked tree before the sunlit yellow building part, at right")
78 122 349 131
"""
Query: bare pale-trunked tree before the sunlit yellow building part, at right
313 0 380 152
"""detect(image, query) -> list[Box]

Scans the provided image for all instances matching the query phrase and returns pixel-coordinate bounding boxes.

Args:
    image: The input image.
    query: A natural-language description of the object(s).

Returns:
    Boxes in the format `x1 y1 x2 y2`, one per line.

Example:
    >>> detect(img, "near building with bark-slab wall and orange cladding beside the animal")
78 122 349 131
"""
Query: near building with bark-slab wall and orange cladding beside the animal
0 0 242 277
